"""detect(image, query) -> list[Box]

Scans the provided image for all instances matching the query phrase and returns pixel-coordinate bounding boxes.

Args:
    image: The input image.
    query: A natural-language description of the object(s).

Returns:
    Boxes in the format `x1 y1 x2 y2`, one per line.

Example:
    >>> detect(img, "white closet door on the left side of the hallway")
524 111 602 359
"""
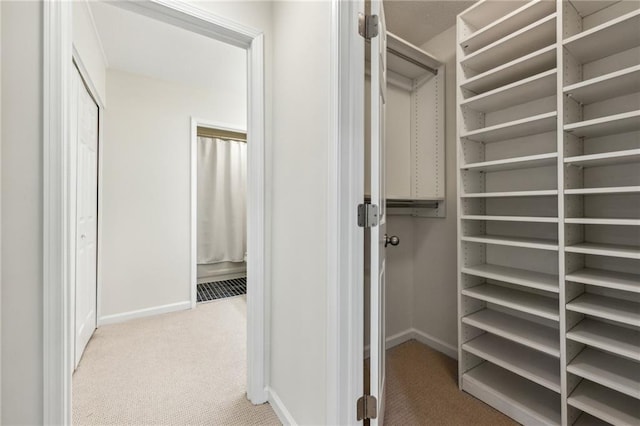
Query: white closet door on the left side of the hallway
72 68 98 368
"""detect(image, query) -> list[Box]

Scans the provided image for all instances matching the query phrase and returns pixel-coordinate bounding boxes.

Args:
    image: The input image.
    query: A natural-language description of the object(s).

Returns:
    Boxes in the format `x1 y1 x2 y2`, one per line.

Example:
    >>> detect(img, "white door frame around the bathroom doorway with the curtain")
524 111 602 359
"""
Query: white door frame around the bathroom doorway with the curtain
189 117 246 309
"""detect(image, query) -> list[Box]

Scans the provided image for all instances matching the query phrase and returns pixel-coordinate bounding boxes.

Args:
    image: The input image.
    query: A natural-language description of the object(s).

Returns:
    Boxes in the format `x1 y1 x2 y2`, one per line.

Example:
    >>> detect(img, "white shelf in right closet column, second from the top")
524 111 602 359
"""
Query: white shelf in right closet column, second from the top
564 65 640 104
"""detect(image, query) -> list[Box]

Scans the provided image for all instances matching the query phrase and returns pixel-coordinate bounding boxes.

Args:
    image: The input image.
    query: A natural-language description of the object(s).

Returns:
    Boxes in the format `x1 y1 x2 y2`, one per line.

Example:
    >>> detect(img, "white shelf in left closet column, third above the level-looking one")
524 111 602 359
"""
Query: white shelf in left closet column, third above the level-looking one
460 68 556 112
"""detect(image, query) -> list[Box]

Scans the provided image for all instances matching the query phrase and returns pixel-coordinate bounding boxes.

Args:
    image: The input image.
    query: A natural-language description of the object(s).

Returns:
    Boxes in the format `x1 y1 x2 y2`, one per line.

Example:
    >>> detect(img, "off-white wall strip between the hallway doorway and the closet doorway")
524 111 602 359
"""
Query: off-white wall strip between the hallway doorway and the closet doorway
271 2 331 424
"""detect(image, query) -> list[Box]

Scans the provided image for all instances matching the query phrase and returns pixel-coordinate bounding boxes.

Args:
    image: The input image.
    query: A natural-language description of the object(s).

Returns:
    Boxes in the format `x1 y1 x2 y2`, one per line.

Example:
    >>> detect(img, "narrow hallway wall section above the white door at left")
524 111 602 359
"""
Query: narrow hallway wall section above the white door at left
71 0 107 104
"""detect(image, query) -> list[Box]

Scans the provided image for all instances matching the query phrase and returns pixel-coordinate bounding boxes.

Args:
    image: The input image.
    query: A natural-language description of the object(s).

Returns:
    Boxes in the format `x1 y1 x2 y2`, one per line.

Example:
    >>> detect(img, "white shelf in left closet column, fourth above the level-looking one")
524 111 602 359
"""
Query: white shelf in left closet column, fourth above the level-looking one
460 43 556 94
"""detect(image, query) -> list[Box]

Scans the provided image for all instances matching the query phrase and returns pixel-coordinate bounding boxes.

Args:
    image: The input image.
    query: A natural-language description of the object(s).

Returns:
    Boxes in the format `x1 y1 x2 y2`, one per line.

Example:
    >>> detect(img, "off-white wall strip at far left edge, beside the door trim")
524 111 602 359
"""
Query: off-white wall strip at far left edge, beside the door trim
0 2 43 425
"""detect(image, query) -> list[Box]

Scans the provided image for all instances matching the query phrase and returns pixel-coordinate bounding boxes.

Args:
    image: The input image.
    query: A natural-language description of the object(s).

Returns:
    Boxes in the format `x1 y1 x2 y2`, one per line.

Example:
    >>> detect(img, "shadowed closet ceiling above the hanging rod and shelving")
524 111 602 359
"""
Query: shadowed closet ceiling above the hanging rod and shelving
384 0 475 46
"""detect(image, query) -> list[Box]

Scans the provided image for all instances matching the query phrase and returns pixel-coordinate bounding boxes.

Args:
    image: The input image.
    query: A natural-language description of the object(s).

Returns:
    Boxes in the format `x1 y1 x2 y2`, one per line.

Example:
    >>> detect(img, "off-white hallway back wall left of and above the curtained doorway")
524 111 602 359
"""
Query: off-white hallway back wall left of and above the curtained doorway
99 66 247 317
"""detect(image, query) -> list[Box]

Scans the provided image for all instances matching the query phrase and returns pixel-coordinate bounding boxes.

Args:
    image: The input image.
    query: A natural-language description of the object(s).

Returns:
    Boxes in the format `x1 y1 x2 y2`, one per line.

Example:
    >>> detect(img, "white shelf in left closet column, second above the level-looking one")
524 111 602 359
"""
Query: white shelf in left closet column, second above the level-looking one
460 111 566 143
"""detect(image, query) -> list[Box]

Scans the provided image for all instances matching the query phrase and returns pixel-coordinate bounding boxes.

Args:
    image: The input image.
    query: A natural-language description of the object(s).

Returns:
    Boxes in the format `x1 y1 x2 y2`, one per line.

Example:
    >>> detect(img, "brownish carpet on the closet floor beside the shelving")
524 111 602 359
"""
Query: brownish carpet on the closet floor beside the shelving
384 340 517 426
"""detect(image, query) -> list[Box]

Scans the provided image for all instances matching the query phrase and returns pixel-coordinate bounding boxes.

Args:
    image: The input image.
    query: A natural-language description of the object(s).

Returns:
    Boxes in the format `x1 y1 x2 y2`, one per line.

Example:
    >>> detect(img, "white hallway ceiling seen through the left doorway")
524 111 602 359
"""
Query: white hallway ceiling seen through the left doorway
88 1 247 89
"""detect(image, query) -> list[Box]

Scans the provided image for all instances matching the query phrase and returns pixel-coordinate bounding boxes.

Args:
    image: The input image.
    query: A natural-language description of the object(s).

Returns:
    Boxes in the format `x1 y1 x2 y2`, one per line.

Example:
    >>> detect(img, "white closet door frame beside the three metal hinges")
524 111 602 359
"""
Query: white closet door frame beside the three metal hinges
326 0 365 425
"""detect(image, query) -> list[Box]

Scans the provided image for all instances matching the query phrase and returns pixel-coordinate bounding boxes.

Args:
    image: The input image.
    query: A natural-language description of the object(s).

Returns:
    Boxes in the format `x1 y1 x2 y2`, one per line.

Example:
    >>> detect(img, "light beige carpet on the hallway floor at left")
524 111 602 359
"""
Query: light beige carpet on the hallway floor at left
73 297 280 425
